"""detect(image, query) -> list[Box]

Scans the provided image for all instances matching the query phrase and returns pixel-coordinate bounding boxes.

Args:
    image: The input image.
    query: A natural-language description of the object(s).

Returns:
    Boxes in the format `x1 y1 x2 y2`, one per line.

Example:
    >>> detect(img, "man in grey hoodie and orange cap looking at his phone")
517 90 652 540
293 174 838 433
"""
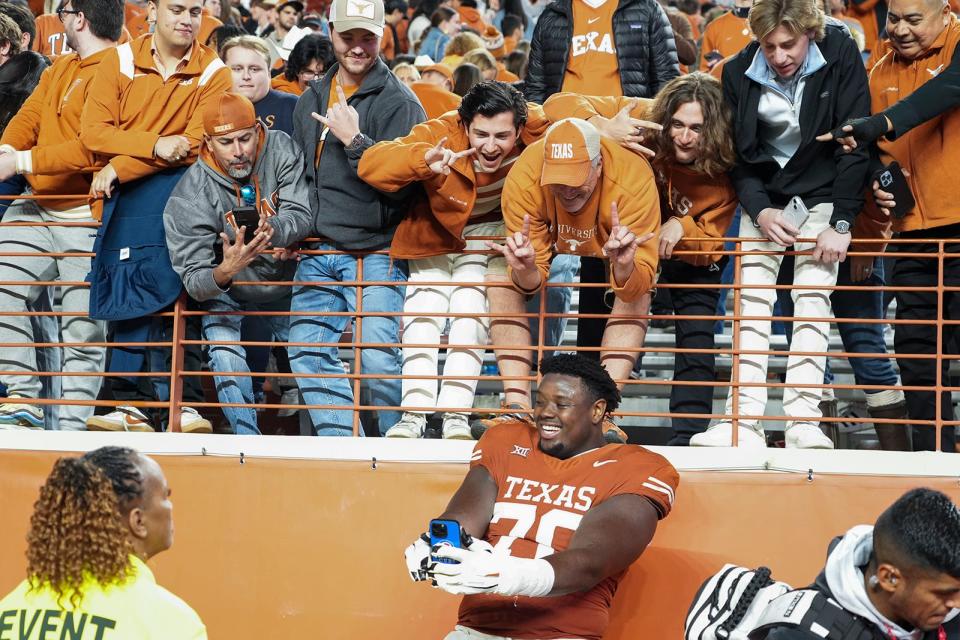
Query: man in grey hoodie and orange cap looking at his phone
163 93 313 434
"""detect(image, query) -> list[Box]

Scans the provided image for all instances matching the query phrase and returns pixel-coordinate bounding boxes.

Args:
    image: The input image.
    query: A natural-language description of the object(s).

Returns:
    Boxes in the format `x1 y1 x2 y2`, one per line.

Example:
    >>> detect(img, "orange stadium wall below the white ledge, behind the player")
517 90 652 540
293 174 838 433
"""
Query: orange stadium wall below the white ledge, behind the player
0 444 960 640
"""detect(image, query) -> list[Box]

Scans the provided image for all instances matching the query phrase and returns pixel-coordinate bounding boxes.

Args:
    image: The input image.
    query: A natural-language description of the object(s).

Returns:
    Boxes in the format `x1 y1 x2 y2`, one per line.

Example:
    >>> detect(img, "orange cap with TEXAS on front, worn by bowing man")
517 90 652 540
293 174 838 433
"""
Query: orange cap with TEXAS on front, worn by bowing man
540 118 600 187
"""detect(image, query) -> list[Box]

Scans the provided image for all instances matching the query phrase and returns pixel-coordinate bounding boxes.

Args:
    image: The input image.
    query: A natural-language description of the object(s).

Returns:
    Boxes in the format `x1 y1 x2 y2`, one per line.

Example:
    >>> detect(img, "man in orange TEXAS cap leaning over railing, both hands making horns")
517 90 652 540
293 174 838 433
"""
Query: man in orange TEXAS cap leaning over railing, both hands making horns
489 118 660 432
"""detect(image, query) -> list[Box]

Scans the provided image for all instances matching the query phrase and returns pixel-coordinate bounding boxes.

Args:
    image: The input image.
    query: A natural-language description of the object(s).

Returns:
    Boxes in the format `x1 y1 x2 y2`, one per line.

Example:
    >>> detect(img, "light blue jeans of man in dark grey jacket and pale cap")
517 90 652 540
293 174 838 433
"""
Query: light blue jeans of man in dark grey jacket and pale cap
289 243 409 436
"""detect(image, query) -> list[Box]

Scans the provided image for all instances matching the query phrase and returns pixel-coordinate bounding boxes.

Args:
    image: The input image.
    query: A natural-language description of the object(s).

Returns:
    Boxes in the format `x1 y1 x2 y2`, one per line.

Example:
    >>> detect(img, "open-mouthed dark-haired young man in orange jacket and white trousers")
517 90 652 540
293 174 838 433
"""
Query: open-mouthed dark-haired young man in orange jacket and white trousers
358 82 548 440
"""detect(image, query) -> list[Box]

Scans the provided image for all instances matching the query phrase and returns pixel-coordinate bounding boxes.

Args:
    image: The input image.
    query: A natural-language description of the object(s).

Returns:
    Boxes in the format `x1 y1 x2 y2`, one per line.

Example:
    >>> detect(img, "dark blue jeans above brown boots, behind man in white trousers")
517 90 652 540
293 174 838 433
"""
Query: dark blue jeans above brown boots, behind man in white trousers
777 256 900 394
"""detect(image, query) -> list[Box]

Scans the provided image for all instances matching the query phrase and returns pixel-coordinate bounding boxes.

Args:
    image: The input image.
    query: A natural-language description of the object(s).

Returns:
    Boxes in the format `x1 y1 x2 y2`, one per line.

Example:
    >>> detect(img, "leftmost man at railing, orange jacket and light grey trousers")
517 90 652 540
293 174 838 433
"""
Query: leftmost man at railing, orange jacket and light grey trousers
0 0 123 430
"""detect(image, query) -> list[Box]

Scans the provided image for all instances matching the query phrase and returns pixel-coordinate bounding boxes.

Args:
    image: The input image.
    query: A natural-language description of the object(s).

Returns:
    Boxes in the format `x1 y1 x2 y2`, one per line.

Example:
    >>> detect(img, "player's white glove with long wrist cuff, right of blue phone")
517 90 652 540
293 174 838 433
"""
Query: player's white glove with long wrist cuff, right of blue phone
427 544 555 597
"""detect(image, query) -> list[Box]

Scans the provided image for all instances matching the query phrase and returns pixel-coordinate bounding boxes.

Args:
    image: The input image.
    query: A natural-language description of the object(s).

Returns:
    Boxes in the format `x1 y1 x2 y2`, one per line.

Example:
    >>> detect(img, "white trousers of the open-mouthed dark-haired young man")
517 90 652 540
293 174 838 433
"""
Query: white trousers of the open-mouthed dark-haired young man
403 223 500 411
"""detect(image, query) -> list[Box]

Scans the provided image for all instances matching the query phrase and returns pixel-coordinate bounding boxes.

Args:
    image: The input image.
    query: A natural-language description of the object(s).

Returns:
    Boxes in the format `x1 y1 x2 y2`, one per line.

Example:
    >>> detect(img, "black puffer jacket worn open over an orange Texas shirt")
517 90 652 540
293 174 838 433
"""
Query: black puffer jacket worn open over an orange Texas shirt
525 0 680 104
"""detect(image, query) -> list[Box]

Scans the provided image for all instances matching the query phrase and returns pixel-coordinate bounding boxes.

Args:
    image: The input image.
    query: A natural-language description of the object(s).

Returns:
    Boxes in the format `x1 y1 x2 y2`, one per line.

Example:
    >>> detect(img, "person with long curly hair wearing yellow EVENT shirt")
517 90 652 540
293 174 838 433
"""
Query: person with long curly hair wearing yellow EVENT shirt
0 447 207 640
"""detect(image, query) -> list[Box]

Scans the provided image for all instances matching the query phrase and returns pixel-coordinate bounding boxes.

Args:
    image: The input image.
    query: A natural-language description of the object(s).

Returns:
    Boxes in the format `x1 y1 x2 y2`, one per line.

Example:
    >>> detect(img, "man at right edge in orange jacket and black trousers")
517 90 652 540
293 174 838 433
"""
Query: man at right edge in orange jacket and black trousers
870 0 960 451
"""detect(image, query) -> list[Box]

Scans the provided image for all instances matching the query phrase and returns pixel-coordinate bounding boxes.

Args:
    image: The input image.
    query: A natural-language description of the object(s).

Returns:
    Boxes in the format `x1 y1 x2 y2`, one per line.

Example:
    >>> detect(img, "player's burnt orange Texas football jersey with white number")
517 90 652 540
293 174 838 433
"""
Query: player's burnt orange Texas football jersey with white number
459 422 680 640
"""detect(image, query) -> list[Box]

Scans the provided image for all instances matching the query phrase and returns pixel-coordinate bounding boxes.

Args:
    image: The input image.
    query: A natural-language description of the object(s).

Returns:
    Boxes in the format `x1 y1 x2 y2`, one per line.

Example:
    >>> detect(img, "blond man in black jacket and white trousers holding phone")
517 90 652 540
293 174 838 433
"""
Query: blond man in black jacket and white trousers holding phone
690 0 869 449
